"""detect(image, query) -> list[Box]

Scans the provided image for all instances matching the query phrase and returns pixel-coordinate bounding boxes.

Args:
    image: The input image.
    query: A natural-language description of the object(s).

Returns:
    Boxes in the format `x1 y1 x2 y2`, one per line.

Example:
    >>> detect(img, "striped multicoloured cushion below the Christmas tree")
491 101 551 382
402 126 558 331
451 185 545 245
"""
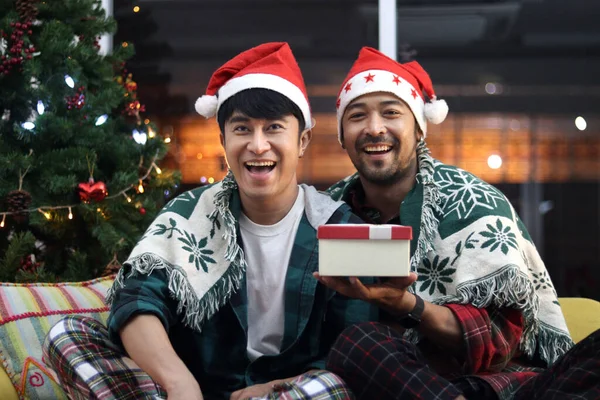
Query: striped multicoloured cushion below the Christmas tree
0 276 114 400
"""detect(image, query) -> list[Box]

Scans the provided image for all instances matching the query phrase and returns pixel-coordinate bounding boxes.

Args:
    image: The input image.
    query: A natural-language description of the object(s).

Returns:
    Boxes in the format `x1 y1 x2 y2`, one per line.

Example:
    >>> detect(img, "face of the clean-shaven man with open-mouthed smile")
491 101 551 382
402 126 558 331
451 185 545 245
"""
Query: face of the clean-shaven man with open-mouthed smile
221 111 311 201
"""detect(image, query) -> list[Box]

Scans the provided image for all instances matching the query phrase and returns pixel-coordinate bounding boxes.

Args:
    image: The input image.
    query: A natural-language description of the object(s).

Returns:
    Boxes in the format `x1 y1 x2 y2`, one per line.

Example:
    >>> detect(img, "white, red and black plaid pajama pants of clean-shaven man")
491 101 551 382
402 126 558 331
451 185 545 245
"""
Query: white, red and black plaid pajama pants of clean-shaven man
43 316 354 400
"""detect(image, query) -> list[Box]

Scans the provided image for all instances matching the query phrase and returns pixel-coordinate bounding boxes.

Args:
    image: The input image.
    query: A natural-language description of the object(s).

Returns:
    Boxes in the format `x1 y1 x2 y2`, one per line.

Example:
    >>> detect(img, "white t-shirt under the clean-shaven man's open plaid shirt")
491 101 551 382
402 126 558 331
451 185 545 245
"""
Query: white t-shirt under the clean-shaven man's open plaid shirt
240 186 304 361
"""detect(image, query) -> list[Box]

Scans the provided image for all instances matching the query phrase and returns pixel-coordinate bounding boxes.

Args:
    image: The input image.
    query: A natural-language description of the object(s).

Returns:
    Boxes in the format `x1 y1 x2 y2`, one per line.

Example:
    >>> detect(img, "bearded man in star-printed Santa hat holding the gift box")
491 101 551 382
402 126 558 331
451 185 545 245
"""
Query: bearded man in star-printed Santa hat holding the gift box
315 48 600 399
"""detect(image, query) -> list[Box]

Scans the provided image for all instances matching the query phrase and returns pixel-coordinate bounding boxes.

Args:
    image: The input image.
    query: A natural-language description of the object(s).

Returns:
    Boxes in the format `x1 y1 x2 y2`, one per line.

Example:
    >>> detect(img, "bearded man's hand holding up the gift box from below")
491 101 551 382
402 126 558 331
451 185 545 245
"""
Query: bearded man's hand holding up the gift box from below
313 272 417 315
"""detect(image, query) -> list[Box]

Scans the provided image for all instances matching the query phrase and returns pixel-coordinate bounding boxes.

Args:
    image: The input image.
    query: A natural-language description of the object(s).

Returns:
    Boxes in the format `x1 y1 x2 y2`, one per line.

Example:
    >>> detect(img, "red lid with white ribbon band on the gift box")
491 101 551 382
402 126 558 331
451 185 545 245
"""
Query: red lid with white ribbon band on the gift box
317 224 412 240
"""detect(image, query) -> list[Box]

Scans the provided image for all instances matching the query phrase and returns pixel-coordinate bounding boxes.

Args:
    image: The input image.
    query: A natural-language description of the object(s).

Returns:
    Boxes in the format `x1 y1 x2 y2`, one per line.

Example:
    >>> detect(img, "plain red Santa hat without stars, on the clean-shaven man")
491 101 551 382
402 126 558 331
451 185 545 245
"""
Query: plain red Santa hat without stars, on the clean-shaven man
196 42 312 128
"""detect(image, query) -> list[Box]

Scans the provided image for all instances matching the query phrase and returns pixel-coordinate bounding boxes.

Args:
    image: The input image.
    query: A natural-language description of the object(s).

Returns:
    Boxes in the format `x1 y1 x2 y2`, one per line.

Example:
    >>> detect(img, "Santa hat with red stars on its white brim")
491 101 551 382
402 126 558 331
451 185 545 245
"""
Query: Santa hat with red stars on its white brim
337 47 448 143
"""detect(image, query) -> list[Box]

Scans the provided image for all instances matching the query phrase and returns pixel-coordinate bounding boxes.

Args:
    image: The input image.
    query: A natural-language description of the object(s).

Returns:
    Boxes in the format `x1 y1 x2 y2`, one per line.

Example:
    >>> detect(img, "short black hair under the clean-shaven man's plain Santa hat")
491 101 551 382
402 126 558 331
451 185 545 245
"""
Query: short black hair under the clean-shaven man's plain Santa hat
217 88 306 133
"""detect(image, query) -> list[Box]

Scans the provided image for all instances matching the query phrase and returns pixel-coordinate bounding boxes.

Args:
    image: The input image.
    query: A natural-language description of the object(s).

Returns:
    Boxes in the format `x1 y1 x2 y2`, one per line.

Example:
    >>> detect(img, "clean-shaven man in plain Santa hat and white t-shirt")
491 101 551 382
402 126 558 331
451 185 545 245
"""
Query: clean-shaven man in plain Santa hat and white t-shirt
45 43 377 400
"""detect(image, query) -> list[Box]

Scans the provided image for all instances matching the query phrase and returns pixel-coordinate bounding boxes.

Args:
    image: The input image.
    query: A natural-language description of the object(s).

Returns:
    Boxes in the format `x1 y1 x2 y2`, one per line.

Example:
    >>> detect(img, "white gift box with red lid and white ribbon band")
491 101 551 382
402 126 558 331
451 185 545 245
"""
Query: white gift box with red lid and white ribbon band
317 224 412 276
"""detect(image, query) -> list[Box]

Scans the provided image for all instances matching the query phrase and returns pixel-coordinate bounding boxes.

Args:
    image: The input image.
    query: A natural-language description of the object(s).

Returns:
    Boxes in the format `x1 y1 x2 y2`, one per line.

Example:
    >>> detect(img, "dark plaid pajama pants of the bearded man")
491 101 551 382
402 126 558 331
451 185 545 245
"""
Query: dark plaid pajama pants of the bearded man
327 323 600 400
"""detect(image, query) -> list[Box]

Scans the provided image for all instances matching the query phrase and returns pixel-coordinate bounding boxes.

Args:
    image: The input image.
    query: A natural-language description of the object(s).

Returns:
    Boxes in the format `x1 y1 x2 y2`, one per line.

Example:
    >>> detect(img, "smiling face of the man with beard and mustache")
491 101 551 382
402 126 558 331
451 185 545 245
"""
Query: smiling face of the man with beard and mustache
342 92 418 186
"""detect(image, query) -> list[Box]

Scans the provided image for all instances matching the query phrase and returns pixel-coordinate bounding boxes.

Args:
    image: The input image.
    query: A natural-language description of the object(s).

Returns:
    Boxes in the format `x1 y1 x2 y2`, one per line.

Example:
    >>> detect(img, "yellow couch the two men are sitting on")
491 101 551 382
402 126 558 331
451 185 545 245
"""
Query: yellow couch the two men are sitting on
0 297 600 400
